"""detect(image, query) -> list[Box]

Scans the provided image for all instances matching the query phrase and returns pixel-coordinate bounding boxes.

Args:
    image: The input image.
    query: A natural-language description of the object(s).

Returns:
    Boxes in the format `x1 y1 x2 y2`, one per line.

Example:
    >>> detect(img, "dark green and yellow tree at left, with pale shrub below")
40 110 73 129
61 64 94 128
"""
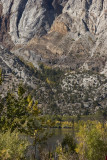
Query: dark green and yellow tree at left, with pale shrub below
0 84 54 160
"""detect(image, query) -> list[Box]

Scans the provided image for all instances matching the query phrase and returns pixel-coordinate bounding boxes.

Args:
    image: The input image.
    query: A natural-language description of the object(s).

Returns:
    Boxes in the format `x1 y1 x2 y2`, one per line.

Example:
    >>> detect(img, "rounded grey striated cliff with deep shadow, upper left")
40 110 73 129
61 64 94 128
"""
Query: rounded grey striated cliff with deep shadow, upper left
1 0 67 44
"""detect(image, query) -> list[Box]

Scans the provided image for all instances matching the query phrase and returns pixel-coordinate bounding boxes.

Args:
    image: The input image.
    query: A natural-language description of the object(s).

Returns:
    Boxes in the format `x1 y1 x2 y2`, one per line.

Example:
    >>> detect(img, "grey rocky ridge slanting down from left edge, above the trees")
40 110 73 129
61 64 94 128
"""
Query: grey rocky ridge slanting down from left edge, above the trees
0 46 38 95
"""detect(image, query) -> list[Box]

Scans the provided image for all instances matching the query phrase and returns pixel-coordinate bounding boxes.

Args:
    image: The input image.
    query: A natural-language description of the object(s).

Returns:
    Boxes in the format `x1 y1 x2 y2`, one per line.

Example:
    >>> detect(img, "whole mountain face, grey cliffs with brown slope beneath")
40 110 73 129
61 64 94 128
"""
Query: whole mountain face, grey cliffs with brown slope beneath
0 0 107 75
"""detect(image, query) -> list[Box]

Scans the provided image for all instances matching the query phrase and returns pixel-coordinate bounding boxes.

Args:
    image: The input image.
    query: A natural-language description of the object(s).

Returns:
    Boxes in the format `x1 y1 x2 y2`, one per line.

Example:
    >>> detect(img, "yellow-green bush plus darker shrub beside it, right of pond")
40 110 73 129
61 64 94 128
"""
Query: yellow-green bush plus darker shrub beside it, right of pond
56 121 107 160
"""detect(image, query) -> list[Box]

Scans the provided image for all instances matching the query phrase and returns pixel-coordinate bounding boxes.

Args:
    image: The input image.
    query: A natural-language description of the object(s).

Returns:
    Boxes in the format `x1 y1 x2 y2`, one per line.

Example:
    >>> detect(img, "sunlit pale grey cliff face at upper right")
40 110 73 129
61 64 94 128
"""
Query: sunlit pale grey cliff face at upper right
63 0 107 34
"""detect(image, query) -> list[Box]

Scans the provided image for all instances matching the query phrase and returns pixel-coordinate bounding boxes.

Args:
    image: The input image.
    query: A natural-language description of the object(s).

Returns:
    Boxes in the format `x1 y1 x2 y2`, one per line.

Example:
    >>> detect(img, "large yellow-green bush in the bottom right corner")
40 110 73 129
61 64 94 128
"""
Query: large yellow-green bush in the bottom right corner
76 121 107 160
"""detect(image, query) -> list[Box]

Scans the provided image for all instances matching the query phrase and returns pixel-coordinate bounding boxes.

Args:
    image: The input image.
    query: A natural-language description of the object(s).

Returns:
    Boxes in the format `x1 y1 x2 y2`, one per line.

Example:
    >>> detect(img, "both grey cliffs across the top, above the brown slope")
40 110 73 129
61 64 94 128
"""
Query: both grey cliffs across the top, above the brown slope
0 0 107 44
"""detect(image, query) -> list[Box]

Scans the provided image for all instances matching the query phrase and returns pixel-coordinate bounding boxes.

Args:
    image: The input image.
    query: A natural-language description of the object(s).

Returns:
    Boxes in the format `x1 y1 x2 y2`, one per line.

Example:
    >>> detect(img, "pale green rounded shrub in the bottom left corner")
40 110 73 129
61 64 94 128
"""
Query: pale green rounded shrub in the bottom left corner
0 131 29 160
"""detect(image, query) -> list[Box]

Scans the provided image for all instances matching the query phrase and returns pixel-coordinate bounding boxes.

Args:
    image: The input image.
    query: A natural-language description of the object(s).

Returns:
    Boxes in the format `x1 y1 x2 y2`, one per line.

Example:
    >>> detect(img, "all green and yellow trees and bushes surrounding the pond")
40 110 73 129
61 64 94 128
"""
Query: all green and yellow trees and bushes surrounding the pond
0 74 107 160
